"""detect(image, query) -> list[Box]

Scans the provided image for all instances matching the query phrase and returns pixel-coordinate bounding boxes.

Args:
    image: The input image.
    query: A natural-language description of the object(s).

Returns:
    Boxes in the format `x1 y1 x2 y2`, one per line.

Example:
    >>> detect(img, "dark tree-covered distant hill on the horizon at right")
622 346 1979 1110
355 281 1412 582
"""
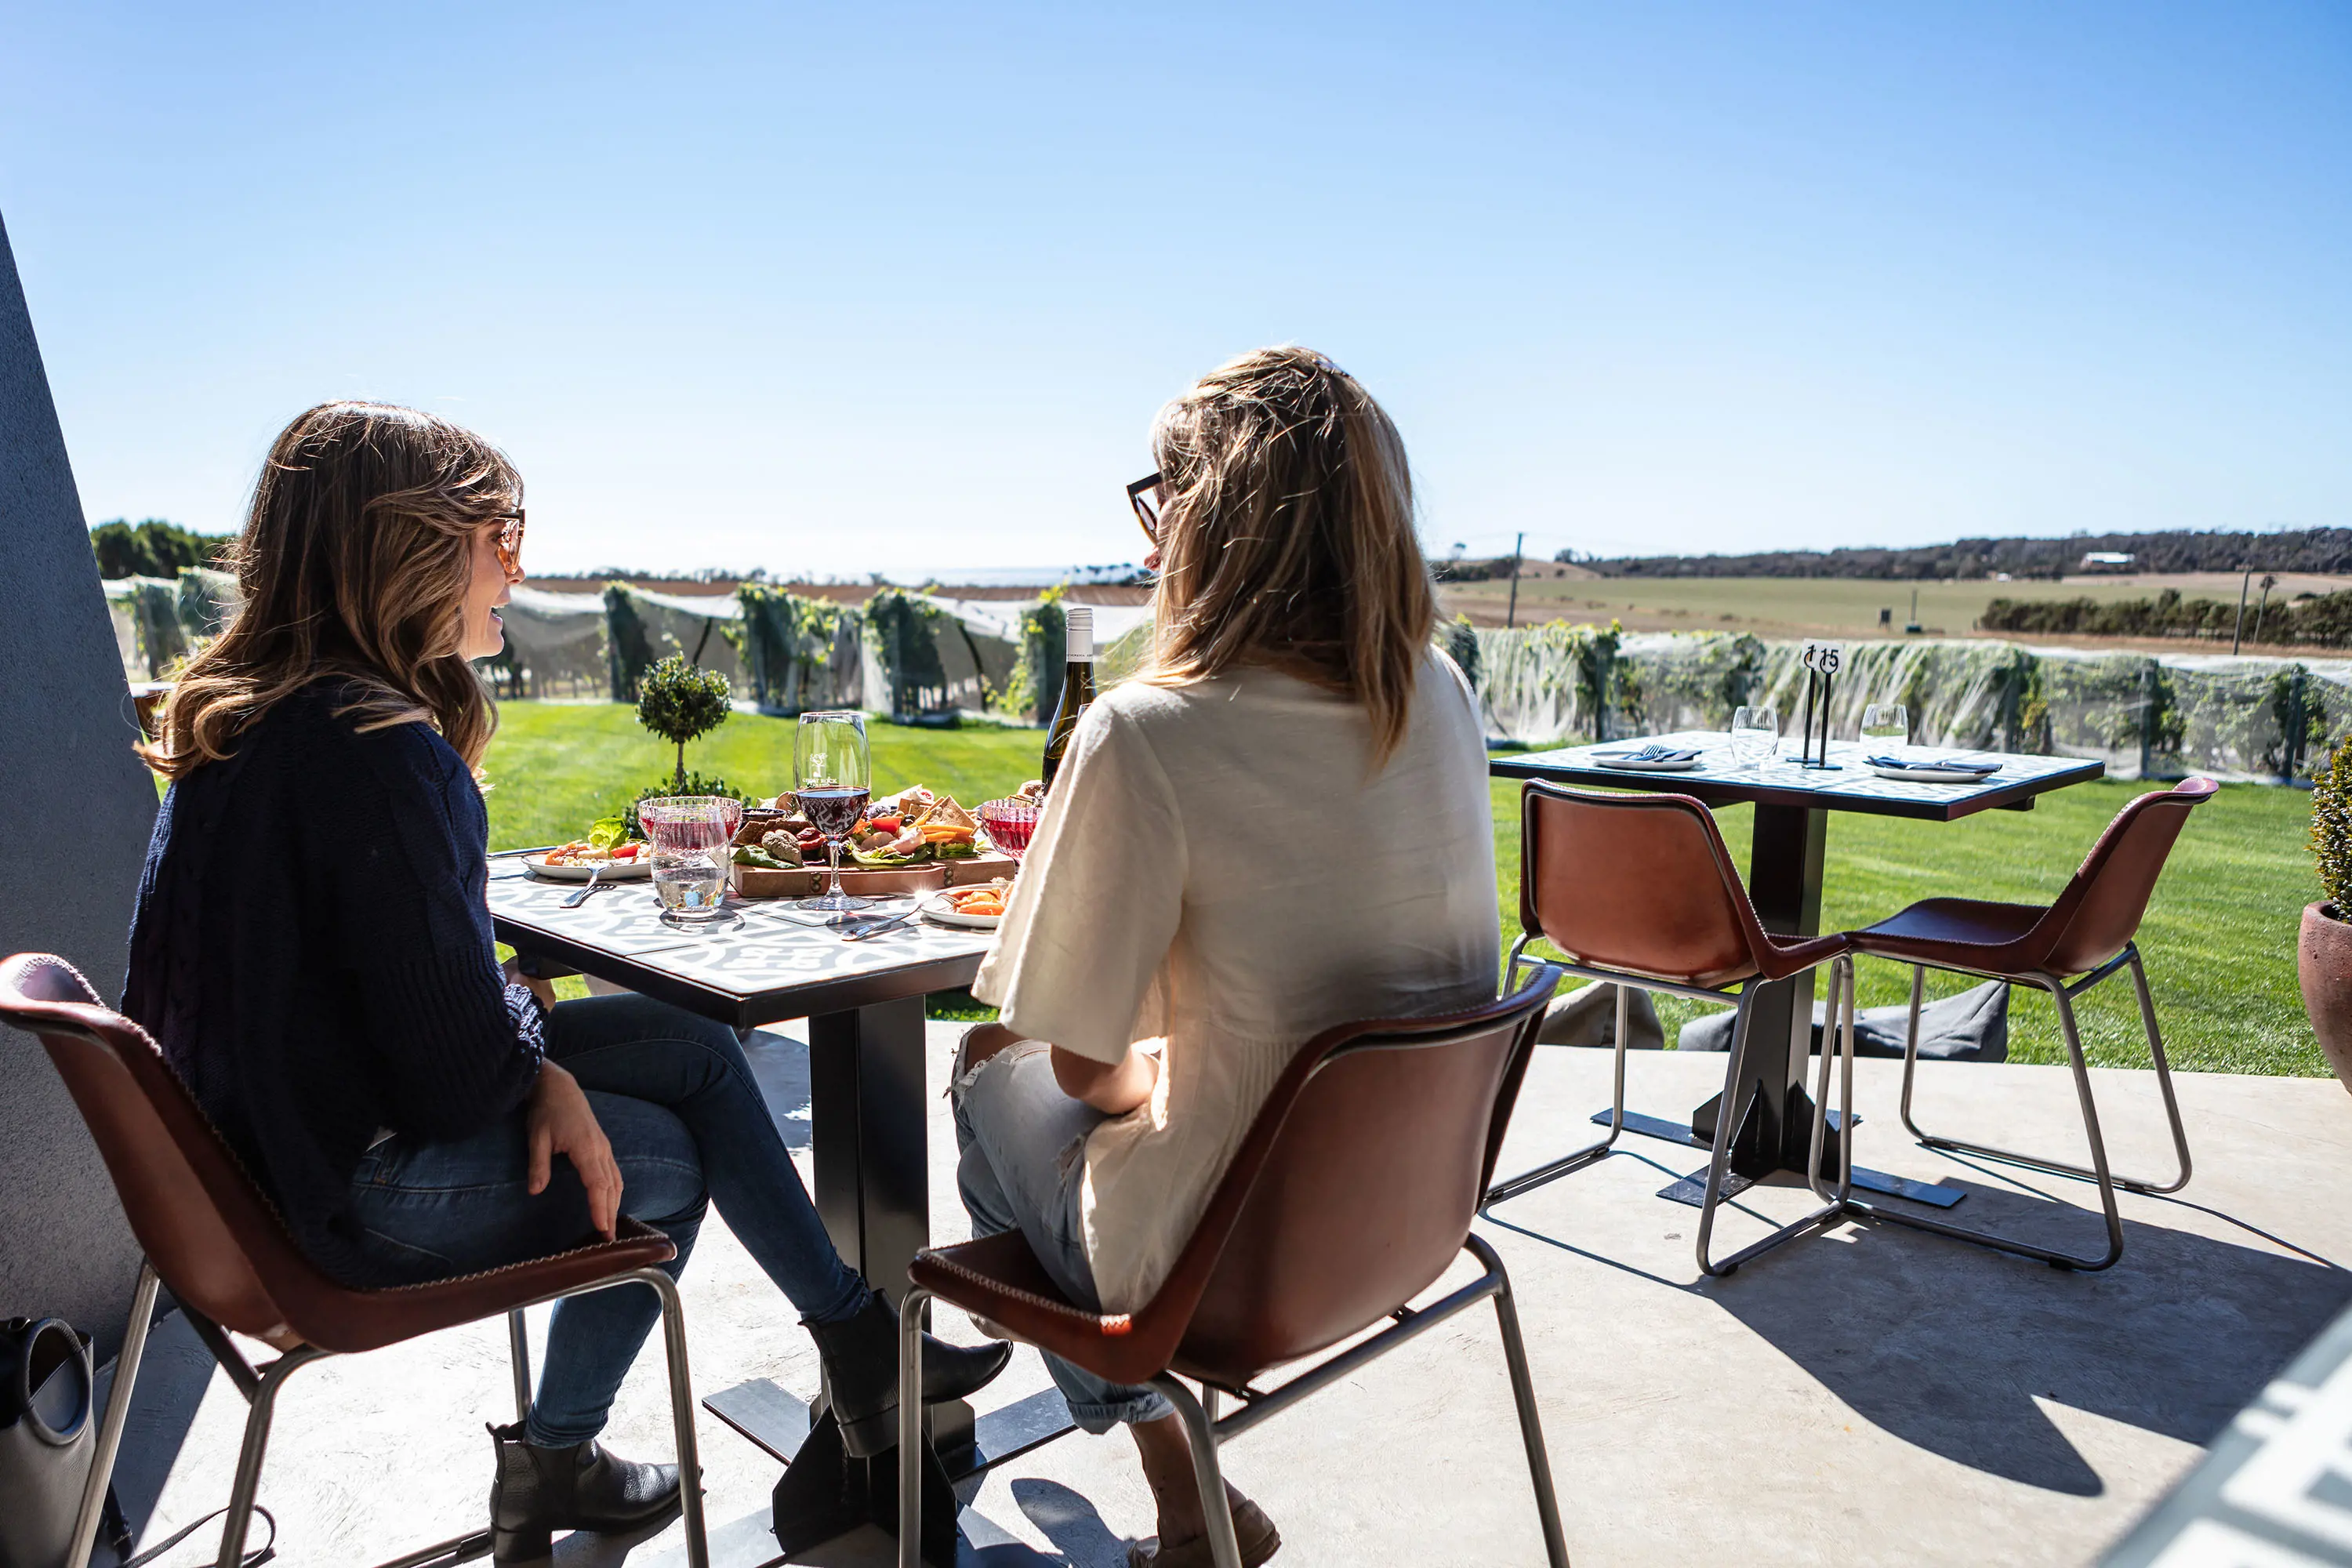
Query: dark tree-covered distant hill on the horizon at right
1559 529 2352 581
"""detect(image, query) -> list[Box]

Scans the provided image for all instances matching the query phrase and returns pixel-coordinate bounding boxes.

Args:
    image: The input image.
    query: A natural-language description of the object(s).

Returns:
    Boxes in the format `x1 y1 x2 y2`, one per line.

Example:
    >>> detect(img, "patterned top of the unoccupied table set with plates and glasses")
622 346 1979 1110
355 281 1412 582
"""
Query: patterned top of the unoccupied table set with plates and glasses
1489 729 2107 822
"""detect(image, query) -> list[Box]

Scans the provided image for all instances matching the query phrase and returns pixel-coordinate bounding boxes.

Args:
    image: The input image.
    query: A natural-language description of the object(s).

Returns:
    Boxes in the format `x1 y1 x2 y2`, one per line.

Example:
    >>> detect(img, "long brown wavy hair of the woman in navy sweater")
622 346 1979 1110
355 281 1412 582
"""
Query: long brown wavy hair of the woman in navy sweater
139 402 522 779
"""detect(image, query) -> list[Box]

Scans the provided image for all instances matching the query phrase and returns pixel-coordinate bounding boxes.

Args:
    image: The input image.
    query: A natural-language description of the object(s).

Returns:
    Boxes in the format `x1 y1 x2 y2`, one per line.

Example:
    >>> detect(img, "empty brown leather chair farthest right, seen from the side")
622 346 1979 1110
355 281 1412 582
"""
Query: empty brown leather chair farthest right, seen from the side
1846 779 2220 1269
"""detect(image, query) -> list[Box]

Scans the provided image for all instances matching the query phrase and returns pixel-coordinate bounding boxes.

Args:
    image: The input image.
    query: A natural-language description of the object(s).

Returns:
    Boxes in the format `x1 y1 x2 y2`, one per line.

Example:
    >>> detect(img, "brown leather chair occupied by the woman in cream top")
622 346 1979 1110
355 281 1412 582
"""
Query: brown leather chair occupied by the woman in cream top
898 966 1569 1568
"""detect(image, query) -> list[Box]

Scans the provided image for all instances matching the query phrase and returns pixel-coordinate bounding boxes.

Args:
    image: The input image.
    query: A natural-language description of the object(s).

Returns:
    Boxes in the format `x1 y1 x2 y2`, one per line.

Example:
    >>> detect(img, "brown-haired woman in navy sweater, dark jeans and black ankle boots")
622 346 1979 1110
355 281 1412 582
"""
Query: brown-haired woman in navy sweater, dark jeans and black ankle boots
122 402 1009 1561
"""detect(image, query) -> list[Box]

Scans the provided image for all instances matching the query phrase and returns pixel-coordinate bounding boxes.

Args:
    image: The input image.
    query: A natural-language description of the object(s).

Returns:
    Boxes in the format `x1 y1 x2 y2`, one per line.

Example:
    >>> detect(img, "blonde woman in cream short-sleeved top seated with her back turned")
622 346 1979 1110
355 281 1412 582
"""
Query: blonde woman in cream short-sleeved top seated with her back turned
955 348 1498 1568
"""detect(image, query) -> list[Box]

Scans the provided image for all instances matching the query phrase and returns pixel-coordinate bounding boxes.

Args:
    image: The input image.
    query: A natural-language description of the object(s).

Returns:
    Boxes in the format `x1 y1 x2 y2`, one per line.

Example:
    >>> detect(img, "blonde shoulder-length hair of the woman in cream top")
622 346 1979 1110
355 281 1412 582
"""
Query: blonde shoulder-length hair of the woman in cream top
1150 346 1437 764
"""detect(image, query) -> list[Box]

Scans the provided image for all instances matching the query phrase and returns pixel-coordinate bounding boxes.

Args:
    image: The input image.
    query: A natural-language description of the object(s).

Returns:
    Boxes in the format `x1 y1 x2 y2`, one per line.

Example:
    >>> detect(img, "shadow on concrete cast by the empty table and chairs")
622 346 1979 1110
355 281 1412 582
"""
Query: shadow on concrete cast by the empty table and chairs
1489 1161 2352 1497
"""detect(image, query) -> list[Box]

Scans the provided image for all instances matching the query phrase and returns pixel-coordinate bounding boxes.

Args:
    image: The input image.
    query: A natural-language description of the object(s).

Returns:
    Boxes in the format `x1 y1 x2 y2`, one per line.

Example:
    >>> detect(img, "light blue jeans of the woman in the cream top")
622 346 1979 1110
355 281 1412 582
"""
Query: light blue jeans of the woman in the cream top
953 1039 1176 1434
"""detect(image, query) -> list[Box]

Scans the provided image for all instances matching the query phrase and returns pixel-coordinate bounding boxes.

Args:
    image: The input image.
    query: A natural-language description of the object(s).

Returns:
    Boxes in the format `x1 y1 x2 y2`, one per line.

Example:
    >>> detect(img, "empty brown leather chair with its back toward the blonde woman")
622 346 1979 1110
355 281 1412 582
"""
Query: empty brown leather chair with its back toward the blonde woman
1482 781 1853 1274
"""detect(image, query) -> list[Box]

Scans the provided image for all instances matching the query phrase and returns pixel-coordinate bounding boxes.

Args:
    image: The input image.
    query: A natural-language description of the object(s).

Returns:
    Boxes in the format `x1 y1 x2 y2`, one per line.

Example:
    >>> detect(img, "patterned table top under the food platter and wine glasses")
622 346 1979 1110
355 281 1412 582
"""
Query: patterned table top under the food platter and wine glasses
489 855 993 1025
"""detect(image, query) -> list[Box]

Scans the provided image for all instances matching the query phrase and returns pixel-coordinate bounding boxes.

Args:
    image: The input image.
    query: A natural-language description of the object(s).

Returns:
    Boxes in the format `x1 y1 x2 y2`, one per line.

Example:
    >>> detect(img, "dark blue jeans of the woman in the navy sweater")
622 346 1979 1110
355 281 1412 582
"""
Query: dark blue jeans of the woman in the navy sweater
350 996 866 1448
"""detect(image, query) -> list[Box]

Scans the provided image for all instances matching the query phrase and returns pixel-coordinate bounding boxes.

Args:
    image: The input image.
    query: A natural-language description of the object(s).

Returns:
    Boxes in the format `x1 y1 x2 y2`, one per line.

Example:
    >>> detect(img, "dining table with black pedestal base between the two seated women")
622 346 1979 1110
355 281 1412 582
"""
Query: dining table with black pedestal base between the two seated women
489 851 1070 1568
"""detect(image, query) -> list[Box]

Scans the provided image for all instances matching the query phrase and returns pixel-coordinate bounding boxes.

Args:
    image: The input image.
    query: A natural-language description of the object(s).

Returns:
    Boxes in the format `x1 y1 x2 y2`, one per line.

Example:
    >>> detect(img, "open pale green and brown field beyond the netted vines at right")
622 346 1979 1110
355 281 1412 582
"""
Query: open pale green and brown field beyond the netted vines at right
1439 573 2352 656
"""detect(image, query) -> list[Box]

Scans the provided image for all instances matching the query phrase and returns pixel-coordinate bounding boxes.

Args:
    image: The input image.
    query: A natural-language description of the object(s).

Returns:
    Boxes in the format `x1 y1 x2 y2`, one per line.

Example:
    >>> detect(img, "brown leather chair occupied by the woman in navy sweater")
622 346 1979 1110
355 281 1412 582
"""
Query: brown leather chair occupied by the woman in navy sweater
0 952 710 1568
